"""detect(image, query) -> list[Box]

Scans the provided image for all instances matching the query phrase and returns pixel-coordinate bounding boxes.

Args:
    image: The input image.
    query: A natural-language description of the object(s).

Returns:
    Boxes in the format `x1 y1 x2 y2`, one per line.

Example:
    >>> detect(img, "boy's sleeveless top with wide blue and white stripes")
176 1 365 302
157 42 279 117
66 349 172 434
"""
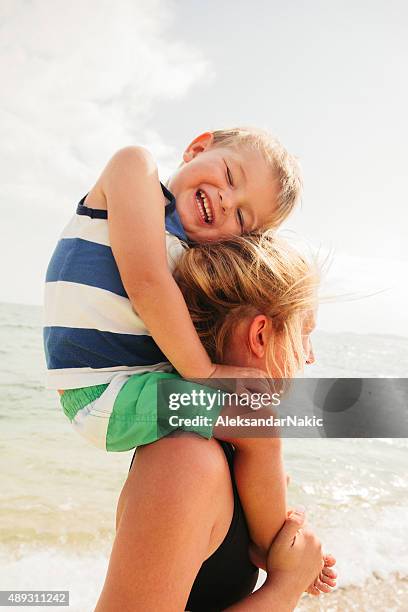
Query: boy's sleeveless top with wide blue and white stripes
43 185 188 389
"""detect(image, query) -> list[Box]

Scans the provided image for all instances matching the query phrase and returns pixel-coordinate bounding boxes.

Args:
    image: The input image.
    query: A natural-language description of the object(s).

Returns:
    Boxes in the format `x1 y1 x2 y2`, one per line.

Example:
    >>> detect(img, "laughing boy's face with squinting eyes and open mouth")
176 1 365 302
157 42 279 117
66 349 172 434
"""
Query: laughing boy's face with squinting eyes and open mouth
168 133 279 242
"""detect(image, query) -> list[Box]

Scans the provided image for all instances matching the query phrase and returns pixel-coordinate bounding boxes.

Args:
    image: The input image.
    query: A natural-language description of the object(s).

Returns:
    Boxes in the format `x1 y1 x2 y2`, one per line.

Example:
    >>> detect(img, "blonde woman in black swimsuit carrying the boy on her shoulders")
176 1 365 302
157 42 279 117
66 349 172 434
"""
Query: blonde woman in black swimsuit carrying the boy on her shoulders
96 232 335 612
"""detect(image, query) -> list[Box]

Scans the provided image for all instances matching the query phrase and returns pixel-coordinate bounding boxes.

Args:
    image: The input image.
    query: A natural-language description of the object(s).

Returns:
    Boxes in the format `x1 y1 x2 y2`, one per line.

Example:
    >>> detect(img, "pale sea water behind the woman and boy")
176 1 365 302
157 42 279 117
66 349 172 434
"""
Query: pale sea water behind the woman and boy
0 304 408 612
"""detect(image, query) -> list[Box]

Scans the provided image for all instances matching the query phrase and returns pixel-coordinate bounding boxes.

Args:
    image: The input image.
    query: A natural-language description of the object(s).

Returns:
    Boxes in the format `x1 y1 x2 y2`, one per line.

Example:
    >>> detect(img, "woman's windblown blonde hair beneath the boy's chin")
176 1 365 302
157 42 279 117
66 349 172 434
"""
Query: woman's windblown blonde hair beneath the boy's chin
176 230 319 378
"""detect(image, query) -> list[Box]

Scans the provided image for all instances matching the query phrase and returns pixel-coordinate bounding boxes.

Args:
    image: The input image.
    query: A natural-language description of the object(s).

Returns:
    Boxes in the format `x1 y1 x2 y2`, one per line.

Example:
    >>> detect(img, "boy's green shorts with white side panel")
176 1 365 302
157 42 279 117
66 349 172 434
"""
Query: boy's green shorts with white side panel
61 372 222 451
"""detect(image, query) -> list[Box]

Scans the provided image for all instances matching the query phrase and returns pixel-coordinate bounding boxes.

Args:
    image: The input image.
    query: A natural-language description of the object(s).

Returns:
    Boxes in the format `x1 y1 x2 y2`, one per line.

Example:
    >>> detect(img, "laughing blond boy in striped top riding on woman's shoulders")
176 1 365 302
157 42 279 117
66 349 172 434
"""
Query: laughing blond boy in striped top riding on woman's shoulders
44 128 301 551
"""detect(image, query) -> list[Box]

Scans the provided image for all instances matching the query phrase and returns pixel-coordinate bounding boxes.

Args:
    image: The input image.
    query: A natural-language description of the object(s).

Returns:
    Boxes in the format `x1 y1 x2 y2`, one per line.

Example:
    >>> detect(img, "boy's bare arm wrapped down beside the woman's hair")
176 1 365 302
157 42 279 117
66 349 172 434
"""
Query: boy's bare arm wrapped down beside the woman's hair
100 147 215 378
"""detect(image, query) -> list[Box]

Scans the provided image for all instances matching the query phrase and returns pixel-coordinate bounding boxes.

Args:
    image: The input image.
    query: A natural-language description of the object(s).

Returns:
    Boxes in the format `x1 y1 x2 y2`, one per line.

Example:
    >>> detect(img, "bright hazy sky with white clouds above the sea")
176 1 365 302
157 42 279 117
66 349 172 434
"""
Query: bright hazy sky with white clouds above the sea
0 0 408 336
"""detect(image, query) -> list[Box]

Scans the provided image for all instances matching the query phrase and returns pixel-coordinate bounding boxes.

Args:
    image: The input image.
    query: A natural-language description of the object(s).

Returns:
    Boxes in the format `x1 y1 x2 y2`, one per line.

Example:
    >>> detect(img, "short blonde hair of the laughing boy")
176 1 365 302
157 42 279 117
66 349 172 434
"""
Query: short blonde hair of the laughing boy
212 127 303 228
